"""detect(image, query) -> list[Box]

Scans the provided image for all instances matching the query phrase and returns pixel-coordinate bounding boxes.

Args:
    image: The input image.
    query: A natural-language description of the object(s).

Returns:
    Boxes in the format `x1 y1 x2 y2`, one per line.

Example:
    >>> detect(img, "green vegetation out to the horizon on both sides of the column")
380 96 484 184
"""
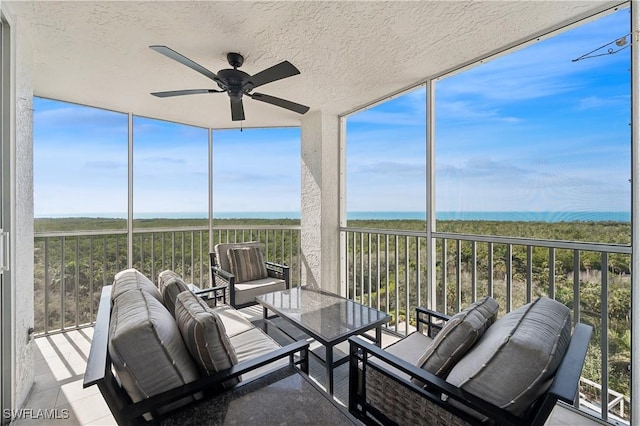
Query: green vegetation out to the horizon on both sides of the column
35 218 631 416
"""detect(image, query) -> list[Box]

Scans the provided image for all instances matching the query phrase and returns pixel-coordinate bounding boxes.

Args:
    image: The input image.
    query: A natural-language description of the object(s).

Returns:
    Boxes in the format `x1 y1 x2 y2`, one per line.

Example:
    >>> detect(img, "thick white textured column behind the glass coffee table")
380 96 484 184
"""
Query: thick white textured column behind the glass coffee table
300 111 340 294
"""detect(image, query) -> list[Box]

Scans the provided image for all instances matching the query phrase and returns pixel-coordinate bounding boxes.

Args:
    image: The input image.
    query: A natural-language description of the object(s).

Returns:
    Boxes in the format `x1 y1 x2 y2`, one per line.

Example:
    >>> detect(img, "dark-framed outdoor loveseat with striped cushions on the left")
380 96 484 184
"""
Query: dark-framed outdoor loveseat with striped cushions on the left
83 269 308 425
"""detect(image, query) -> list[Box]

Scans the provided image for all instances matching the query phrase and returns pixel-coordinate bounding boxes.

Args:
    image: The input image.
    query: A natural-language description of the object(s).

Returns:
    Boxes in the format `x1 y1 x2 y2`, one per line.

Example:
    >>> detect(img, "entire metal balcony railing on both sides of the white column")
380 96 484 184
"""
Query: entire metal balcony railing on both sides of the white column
34 225 631 421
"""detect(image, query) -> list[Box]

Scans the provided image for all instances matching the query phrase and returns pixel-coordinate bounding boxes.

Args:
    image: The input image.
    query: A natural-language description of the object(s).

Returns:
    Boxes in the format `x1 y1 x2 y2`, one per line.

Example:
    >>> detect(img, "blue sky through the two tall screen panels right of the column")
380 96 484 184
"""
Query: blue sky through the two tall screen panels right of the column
347 9 631 216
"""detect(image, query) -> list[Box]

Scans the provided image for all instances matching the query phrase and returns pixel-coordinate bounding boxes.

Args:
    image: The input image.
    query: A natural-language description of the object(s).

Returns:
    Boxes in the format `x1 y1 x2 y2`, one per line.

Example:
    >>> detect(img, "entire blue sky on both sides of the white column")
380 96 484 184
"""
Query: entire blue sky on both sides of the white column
34 9 630 217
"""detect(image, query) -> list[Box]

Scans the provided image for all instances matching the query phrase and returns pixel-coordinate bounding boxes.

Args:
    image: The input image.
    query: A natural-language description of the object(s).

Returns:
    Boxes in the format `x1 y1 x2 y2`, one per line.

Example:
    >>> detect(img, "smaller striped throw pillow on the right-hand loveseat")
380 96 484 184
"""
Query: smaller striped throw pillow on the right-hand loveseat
417 296 499 378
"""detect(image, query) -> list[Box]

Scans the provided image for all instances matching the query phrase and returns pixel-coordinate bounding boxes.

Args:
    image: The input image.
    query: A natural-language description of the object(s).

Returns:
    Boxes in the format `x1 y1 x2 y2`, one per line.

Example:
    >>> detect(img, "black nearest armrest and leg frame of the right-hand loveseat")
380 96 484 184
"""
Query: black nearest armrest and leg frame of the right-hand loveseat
349 336 521 425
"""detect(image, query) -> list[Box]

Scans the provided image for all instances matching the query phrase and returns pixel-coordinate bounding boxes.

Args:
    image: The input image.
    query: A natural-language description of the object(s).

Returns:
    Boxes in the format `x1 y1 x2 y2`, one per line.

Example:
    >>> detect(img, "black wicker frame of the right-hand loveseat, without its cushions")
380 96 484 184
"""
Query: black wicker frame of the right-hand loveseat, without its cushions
349 308 592 425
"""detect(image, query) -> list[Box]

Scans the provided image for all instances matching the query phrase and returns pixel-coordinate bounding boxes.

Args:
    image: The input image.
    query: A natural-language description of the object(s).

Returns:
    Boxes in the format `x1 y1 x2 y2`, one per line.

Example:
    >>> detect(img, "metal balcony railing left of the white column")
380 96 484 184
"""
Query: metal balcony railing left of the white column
34 226 301 335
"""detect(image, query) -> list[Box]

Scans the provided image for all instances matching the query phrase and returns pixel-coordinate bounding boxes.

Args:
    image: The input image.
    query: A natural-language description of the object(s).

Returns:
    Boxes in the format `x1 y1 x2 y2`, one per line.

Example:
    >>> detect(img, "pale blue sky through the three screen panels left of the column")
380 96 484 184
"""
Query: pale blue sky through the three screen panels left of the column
34 98 300 217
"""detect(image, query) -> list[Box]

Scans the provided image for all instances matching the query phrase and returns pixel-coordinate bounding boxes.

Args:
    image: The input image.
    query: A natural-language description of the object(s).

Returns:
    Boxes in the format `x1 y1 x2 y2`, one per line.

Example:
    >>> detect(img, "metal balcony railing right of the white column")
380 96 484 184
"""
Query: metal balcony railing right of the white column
341 228 631 422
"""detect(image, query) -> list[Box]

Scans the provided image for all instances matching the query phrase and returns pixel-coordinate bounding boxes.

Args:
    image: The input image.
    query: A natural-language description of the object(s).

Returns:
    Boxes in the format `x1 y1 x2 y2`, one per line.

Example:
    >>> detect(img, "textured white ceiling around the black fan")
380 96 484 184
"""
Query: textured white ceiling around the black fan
3 1 619 128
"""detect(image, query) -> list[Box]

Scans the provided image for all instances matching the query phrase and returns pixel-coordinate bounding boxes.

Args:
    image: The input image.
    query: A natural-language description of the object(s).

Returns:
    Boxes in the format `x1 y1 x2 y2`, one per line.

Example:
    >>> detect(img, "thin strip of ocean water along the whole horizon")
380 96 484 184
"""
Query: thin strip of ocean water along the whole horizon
37 211 631 222
